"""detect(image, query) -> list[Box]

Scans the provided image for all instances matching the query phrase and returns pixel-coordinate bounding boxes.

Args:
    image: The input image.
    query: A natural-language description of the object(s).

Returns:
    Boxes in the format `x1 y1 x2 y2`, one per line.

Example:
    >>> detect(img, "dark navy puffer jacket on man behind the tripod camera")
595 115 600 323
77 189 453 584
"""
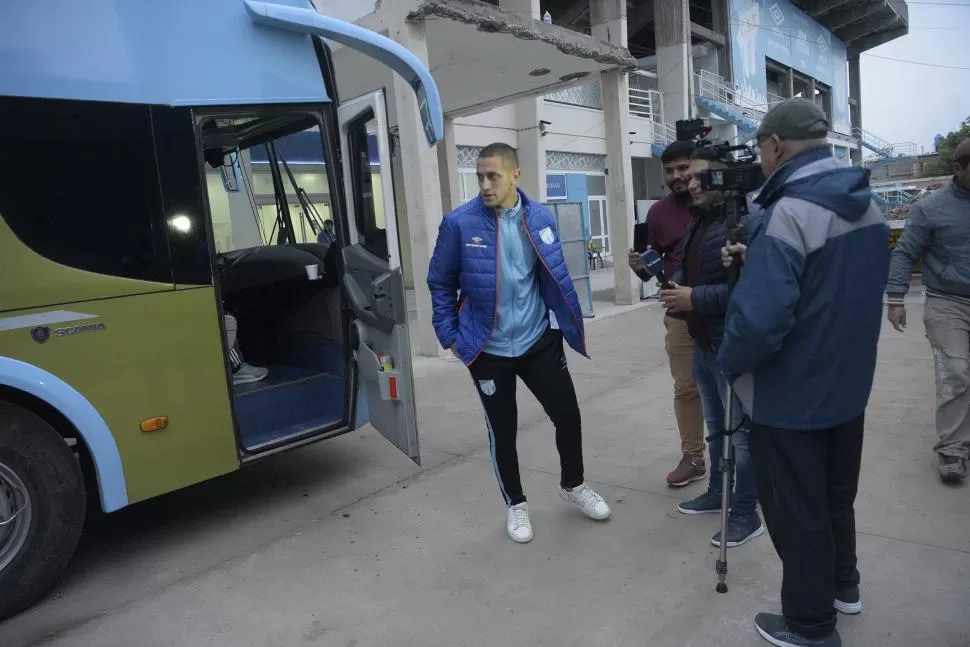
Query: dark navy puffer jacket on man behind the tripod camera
673 200 761 350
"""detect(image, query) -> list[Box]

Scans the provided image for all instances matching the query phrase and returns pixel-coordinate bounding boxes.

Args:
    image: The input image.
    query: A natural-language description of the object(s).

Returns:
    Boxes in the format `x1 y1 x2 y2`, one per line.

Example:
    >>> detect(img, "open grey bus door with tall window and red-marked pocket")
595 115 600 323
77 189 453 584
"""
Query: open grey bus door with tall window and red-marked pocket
337 92 421 464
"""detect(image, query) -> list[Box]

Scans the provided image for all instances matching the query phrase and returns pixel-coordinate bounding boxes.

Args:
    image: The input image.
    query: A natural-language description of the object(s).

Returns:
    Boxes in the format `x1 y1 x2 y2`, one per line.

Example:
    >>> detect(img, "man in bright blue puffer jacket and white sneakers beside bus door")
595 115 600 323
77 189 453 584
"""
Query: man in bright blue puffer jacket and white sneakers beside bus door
428 144 610 543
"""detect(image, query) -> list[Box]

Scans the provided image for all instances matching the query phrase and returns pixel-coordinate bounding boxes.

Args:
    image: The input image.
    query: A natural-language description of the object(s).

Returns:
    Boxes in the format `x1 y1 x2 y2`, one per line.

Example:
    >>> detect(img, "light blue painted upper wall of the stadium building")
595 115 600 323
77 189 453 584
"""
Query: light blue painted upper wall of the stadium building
729 0 852 134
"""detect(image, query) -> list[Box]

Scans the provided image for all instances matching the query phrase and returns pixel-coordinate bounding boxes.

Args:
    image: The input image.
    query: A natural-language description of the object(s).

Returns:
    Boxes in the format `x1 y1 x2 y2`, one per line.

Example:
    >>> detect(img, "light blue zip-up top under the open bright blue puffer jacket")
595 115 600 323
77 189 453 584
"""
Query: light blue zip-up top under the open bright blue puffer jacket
483 196 549 357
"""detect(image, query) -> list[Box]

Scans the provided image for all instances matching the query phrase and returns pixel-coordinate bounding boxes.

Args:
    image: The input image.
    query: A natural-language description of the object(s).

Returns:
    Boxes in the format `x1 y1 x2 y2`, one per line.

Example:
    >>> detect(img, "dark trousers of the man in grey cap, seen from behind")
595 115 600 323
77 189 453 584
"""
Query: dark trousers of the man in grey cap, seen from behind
748 415 865 638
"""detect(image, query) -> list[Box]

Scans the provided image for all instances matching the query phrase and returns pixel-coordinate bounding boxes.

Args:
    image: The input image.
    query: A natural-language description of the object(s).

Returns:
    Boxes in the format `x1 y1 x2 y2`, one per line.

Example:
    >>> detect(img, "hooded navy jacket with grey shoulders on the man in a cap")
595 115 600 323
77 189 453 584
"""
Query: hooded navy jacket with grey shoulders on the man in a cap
718 148 889 430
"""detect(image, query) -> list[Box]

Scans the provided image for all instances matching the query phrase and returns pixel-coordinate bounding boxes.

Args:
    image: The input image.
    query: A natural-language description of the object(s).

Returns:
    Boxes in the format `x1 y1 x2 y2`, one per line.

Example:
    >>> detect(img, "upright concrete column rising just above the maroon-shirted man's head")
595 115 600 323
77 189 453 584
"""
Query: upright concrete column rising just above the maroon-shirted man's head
656 0 694 124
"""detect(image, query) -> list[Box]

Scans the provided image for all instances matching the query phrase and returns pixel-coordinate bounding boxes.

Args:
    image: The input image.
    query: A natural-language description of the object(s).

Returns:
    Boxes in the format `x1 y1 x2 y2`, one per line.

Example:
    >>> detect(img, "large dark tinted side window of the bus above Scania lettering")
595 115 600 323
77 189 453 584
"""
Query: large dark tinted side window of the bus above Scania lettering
0 97 173 284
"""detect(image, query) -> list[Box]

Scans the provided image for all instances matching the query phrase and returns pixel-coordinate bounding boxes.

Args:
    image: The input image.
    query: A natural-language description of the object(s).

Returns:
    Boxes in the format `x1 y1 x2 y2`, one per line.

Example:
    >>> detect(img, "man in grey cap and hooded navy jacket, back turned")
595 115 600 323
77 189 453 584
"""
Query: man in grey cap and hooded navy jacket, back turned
718 99 889 647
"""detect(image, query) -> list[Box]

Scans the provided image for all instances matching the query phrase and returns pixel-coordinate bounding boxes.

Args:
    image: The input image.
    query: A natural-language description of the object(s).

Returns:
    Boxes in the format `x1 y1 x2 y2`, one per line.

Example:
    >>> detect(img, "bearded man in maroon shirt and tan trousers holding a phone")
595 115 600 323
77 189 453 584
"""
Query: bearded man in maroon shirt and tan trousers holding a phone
629 142 706 487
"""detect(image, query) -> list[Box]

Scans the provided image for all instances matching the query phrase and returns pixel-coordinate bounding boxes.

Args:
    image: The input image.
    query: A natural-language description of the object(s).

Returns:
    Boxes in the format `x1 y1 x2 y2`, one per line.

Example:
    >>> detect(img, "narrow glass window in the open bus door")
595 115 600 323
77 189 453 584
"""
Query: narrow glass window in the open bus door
348 120 384 260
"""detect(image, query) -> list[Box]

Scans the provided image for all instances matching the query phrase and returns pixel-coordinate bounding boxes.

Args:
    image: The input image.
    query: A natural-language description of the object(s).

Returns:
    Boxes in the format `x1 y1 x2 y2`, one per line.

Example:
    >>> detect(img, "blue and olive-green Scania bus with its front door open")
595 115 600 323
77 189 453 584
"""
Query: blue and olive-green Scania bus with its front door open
0 0 444 619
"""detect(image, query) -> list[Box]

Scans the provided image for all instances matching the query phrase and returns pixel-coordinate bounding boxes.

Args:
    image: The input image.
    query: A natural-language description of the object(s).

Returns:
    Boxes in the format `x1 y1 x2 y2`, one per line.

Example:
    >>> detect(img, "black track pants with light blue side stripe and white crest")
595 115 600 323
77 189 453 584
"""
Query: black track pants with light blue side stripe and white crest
468 328 583 506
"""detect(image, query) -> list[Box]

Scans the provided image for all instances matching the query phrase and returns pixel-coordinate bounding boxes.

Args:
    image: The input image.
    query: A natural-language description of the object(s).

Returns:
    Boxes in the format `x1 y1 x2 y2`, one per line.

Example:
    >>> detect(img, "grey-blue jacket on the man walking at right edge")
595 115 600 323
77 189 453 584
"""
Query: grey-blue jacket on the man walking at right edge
886 182 970 305
